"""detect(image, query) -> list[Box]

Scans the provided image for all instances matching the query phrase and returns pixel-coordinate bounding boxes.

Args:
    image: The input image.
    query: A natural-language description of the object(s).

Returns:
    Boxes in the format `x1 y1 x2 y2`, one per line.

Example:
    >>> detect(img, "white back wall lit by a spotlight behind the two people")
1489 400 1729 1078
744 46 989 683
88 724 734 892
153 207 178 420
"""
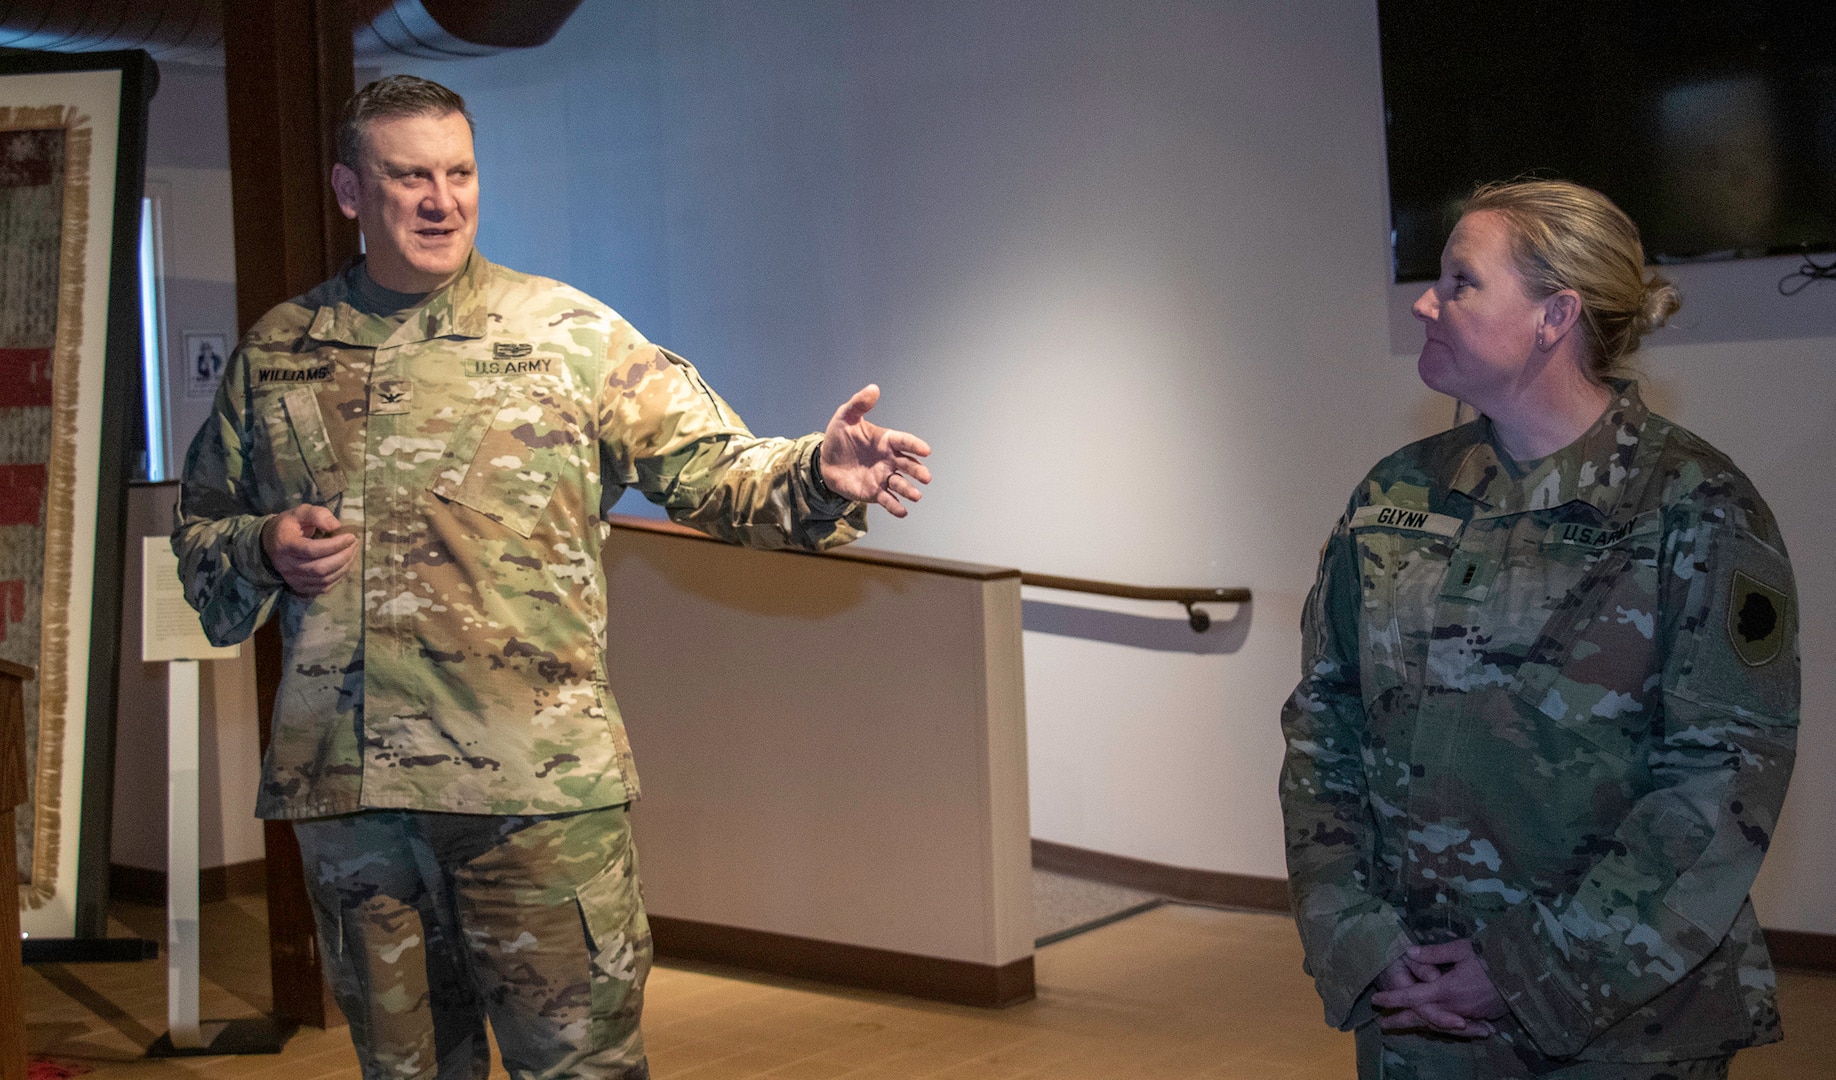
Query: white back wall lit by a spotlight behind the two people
376 0 1836 931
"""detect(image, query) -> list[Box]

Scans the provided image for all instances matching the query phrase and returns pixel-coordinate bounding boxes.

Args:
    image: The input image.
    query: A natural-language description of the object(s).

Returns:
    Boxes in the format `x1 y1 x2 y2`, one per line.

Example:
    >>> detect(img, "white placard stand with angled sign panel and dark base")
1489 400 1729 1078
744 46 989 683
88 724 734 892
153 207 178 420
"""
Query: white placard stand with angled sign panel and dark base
140 536 286 1058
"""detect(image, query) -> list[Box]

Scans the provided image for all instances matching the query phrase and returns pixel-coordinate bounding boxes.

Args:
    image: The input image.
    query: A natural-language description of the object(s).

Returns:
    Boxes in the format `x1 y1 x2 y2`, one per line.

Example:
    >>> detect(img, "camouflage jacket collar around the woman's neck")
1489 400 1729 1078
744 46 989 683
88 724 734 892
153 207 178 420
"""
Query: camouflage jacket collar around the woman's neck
1449 378 1649 520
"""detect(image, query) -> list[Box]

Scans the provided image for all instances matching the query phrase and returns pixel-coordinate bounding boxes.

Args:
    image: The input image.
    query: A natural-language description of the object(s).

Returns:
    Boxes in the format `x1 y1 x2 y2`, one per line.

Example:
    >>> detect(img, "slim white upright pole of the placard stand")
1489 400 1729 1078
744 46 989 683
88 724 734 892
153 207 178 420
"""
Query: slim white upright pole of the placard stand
165 659 206 1049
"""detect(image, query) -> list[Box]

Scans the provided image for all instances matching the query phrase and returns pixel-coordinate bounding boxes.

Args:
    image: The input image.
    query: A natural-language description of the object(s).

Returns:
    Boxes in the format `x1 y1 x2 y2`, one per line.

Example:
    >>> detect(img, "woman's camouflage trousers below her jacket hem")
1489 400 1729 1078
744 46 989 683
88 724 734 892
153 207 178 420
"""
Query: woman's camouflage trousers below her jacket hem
1357 1019 1731 1080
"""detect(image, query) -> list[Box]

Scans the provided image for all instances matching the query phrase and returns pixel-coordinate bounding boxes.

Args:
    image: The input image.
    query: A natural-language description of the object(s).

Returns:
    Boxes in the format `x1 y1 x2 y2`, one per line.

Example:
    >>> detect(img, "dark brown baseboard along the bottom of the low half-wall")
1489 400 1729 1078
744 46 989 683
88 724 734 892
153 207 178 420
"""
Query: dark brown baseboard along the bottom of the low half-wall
650 915 1034 1008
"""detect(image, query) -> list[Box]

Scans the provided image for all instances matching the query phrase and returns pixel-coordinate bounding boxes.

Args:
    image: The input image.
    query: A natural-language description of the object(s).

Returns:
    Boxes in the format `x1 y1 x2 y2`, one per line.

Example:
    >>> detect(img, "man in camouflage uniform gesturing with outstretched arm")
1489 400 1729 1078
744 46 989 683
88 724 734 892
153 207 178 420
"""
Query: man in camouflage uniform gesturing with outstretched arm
173 77 929 1078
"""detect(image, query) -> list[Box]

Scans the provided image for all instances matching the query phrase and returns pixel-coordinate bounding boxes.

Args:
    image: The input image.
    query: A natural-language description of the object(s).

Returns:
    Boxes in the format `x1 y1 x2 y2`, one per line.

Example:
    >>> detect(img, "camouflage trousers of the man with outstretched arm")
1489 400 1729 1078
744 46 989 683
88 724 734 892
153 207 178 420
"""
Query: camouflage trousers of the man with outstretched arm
294 806 650 1080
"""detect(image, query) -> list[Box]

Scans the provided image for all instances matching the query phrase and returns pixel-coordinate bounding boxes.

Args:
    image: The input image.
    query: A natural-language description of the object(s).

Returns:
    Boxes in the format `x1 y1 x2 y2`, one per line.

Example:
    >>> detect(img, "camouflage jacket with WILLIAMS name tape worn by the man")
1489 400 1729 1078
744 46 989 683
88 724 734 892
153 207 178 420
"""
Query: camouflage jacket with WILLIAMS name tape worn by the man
173 252 865 817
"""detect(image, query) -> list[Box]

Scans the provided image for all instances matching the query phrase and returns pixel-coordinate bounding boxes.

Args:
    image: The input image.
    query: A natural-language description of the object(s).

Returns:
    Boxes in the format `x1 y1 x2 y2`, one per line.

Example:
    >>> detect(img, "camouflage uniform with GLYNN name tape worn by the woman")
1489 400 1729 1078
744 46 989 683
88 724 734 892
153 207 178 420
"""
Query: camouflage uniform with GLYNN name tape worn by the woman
1282 382 1797 1076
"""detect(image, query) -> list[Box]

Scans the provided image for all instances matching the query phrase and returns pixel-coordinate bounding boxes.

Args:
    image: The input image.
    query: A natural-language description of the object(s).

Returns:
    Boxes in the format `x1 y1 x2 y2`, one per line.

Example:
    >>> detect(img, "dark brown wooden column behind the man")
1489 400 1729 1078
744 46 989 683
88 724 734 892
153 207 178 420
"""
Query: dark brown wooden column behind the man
224 0 358 1027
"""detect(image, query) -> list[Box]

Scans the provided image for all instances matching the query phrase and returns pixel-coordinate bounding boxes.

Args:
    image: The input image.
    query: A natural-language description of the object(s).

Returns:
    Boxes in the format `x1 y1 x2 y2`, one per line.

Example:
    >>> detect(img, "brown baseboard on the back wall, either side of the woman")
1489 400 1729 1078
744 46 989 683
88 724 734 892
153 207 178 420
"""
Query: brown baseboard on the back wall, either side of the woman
1034 839 1836 972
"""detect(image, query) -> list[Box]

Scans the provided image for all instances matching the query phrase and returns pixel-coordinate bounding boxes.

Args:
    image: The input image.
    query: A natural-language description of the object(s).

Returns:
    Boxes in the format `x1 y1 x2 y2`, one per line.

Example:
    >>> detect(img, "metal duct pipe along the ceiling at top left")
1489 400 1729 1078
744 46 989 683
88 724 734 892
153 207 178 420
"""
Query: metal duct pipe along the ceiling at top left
0 0 580 62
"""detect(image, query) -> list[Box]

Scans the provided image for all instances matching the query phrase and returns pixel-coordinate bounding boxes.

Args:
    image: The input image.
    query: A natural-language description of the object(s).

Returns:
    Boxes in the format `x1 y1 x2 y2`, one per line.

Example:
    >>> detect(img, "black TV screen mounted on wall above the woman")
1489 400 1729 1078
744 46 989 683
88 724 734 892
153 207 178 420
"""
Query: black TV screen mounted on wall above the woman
1377 0 1836 281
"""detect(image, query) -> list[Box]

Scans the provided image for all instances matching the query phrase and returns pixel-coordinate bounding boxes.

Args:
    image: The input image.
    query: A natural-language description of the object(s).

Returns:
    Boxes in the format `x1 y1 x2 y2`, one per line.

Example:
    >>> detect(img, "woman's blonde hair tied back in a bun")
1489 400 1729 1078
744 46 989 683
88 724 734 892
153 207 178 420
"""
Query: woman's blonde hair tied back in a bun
1461 180 1682 382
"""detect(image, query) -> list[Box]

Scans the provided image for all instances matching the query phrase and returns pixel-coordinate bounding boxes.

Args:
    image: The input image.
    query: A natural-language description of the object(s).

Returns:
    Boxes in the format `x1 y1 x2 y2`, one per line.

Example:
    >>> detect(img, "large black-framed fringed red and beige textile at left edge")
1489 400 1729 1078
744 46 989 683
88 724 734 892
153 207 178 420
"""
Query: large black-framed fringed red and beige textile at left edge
0 51 156 939
